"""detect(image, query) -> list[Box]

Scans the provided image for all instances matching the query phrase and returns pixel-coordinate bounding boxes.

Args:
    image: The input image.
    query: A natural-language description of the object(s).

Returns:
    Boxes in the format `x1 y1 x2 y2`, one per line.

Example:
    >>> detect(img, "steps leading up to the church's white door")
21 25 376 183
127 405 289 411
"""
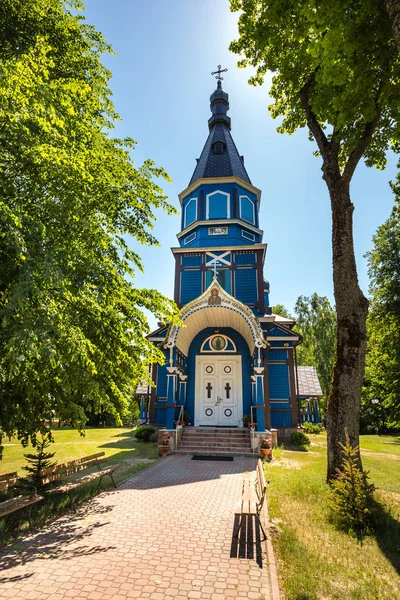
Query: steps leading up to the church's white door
178 427 251 454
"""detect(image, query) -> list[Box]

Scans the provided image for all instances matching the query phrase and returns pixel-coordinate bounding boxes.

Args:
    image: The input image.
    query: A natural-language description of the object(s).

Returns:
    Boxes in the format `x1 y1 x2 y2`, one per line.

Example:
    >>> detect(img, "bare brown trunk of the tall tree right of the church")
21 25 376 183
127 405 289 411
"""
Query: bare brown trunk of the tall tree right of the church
323 171 368 481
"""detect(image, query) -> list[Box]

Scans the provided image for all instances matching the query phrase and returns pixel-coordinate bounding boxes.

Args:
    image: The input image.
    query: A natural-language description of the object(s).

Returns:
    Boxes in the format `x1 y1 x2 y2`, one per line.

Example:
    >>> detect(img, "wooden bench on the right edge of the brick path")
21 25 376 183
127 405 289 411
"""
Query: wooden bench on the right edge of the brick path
233 458 269 542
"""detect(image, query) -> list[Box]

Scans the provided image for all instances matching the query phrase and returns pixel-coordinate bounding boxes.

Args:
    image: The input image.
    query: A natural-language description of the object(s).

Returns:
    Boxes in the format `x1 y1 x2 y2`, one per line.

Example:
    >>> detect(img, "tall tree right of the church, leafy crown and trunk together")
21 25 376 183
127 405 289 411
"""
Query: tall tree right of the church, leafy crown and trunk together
230 0 400 479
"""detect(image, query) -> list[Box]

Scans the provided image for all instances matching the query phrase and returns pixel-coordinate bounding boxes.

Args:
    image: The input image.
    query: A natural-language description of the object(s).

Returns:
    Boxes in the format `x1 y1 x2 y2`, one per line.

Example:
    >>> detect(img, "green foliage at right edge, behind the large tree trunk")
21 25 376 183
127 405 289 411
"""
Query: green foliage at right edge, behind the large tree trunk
361 202 400 431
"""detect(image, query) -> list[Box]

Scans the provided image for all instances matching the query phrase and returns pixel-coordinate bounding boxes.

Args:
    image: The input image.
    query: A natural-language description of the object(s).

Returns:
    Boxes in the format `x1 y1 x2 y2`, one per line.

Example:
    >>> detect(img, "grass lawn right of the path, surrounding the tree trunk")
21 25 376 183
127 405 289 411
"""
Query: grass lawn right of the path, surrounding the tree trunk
265 434 400 600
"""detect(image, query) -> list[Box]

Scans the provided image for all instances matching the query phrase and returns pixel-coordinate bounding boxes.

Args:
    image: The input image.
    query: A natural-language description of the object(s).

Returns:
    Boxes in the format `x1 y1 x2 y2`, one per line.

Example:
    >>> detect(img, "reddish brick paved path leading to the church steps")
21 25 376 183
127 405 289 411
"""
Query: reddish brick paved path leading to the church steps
0 455 270 600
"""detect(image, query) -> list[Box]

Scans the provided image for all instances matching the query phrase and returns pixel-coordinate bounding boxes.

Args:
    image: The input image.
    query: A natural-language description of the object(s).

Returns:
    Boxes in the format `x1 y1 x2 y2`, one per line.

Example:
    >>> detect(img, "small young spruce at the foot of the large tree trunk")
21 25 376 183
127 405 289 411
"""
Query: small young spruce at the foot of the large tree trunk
328 430 375 541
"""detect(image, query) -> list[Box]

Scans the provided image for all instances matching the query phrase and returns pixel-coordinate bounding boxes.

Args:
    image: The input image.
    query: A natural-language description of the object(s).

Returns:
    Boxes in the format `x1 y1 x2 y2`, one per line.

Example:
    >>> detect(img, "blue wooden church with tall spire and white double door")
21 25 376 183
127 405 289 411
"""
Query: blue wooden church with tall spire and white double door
149 80 306 431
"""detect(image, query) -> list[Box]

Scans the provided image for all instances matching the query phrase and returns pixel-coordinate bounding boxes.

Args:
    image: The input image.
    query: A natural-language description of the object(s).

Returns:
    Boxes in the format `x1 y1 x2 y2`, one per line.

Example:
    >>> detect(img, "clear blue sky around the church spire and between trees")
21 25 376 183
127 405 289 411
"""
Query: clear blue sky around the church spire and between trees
81 0 396 326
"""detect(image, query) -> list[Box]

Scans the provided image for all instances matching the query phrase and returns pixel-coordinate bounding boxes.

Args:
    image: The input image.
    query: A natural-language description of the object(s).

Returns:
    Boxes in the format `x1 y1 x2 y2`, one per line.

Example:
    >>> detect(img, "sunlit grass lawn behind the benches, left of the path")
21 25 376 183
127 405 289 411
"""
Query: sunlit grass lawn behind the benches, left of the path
0 427 157 482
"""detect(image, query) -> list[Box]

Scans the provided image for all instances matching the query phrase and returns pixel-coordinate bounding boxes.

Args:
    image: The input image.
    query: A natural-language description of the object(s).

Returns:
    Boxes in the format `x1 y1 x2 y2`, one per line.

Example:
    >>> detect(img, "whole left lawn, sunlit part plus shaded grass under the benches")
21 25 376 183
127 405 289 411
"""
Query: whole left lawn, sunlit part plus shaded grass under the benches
0 427 158 543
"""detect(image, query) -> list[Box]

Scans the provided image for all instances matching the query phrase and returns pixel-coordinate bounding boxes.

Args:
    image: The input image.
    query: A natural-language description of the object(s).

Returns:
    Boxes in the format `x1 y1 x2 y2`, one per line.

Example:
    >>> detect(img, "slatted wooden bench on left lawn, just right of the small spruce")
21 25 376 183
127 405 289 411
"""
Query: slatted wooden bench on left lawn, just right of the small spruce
40 452 119 512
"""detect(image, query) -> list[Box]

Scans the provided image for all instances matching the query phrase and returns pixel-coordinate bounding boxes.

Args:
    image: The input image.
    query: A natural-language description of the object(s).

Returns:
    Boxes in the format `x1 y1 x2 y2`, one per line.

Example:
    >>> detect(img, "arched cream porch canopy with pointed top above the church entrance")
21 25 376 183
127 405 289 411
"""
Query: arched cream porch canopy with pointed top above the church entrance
165 278 267 356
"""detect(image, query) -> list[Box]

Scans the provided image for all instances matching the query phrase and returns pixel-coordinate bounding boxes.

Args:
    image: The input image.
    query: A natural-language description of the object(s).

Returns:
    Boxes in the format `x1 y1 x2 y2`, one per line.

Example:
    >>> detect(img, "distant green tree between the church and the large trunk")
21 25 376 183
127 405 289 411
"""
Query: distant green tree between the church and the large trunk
295 294 336 418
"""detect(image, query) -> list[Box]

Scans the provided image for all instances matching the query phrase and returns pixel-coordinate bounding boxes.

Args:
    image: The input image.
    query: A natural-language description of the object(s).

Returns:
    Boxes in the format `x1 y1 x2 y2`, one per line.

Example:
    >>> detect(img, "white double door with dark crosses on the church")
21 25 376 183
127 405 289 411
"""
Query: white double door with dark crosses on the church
195 355 243 427
